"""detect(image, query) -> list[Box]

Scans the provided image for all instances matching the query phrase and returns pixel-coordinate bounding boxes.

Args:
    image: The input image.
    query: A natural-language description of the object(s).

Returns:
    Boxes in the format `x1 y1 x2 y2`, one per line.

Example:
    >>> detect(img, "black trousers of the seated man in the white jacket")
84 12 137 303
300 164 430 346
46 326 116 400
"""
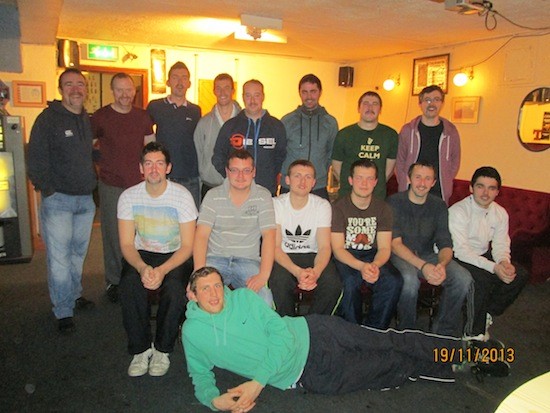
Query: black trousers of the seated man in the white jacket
456 256 529 336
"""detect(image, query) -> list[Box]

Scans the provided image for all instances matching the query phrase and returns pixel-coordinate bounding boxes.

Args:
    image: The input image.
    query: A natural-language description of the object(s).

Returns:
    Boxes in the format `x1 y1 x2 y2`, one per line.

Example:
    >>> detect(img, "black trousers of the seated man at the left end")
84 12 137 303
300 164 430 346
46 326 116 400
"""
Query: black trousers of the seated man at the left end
118 251 190 354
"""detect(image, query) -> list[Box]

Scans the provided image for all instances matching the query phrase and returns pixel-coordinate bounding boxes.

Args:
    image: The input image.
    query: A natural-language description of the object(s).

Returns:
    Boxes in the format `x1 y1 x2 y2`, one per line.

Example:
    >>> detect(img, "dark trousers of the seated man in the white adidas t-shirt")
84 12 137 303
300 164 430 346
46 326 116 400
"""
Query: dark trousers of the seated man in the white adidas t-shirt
268 253 342 316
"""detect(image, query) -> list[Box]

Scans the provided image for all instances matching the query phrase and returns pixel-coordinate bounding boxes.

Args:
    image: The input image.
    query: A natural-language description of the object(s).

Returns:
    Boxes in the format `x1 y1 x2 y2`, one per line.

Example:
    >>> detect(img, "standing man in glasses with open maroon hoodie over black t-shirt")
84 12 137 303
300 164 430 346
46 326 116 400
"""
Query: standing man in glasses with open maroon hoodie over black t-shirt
396 85 460 205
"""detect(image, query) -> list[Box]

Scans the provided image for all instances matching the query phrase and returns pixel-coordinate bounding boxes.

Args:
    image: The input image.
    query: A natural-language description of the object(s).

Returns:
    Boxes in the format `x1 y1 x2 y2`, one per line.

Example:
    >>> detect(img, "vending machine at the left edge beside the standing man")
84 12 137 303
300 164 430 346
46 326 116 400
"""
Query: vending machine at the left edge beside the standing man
0 116 33 264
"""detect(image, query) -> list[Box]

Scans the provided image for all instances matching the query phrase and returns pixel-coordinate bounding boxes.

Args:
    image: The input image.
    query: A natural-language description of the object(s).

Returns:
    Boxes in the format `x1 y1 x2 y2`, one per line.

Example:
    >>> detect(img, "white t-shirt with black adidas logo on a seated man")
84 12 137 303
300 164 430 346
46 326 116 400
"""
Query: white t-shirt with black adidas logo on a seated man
273 193 332 254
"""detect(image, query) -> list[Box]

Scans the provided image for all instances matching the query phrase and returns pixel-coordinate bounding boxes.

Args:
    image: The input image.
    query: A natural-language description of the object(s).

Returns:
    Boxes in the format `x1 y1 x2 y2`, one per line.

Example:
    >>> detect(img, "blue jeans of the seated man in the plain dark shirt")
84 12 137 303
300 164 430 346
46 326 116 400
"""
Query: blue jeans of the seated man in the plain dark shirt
391 253 473 337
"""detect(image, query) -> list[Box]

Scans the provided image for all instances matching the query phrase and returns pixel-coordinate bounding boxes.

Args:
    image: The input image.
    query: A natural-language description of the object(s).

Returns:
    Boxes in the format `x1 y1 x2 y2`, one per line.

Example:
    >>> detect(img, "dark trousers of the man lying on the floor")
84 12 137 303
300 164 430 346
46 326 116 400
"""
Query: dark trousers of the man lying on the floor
299 315 462 394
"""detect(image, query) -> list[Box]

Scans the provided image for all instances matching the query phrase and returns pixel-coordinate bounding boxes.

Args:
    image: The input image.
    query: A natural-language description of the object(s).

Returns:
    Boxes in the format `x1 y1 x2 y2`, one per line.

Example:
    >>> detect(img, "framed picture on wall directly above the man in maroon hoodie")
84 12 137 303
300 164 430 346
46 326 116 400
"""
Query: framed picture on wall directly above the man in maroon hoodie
412 54 450 95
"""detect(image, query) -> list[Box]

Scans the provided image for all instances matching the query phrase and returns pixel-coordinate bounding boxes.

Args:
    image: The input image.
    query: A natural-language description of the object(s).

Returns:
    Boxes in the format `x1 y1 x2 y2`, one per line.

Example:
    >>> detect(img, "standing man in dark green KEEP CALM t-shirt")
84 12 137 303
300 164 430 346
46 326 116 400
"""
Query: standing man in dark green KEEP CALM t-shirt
332 92 397 199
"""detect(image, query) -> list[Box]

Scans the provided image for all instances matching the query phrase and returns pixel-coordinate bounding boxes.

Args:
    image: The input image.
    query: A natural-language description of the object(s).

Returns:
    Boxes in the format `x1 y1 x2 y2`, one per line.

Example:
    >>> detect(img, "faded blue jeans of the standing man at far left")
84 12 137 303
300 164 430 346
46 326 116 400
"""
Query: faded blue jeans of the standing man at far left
40 192 95 319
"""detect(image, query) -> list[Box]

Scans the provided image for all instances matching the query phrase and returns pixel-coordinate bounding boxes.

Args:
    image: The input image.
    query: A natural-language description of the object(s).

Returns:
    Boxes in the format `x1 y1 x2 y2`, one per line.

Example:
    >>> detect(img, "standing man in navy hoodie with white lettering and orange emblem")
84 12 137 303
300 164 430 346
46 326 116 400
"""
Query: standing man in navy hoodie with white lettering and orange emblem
212 79 286 195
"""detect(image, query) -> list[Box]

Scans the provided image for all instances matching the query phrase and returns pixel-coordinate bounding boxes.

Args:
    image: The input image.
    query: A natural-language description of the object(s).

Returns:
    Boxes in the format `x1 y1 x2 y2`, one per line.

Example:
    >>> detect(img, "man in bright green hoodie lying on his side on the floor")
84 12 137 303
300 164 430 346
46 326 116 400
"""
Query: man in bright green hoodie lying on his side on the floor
182 267 462 413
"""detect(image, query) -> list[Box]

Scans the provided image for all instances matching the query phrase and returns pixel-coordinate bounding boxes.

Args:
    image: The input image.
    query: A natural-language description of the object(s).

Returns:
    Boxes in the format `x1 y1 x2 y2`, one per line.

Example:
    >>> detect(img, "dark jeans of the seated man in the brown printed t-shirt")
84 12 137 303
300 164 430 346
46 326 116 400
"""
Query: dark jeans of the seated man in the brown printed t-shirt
334 250 403 329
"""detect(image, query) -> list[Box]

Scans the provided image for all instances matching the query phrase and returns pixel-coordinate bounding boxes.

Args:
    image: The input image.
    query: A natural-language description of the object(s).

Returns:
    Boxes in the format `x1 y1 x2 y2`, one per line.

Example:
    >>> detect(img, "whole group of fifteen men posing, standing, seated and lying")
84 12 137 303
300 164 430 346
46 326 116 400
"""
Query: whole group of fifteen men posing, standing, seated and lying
28 62 527 411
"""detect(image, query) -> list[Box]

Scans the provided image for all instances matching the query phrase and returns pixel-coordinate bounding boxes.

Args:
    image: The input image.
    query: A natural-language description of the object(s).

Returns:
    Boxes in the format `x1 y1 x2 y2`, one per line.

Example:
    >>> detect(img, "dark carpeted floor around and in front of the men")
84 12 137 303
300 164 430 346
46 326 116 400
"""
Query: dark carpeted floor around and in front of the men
0 227 550 413
